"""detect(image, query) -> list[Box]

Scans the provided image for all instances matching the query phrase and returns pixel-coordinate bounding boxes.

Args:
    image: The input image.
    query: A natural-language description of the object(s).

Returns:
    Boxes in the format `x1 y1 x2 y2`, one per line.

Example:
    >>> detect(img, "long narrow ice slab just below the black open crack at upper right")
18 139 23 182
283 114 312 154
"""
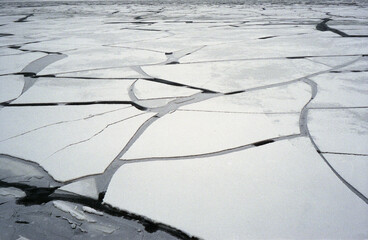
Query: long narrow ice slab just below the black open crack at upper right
181 32 368 63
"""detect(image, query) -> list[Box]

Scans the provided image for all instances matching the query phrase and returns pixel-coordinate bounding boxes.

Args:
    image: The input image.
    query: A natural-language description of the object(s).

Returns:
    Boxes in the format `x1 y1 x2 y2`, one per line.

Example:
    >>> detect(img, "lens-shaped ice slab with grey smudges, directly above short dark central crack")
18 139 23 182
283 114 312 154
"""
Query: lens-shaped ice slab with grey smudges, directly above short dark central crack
142 59 328 92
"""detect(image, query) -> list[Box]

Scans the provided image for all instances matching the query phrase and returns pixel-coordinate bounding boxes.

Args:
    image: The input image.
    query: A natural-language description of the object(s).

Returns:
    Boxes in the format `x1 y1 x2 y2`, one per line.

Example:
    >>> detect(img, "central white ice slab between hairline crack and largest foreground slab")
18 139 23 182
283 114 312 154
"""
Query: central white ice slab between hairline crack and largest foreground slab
122 111 299 159
